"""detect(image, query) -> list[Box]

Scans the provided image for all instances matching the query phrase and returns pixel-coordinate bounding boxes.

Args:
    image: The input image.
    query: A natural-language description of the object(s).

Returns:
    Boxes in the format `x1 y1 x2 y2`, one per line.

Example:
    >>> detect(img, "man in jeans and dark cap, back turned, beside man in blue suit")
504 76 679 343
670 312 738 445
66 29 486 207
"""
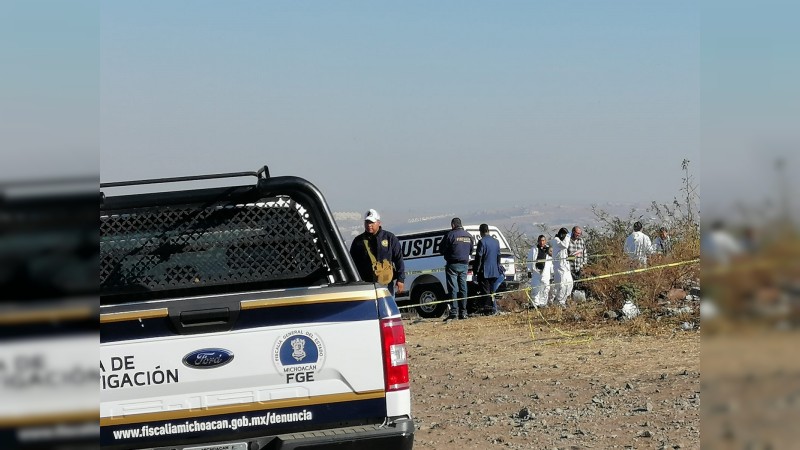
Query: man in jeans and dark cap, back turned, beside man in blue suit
439 217 475 321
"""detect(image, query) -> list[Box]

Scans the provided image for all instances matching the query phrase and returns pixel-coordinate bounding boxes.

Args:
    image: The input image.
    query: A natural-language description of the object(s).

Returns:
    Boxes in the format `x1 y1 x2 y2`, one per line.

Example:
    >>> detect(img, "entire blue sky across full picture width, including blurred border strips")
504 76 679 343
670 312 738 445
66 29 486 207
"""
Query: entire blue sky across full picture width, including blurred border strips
9 0 800 221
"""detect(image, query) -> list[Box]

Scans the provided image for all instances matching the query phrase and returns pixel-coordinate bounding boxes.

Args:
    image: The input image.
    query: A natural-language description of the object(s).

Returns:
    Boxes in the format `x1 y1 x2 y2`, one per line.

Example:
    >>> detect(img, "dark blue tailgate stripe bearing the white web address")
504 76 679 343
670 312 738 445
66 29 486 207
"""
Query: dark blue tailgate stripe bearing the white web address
100 398 386 448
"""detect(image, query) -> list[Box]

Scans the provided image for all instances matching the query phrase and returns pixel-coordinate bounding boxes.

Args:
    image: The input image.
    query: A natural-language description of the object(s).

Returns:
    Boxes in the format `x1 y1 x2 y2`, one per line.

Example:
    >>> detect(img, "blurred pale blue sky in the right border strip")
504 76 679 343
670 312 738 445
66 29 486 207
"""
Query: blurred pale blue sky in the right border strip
701 0 800 221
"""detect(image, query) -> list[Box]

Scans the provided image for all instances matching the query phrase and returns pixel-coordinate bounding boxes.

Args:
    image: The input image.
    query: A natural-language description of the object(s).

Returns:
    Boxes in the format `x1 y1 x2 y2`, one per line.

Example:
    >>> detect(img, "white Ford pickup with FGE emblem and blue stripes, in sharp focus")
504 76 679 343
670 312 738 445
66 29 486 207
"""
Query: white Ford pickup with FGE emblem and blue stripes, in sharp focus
100 167 414 450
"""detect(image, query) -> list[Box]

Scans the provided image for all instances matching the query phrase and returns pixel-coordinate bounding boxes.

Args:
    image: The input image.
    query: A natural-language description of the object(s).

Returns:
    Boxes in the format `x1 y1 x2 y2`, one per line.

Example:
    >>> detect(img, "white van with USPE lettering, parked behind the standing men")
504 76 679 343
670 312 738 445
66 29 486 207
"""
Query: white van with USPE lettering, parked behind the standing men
395 225 519 318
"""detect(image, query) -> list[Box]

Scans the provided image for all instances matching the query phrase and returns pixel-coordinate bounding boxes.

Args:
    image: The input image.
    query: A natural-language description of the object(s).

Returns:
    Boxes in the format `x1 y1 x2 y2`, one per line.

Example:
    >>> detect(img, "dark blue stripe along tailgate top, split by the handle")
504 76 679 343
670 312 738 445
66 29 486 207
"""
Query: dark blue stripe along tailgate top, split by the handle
100 300 382 343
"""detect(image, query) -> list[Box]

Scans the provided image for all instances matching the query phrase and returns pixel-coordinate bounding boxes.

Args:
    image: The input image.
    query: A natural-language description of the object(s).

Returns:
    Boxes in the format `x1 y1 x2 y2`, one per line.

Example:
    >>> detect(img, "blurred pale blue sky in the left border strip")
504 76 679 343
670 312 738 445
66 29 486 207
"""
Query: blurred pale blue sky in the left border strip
0 0 100 181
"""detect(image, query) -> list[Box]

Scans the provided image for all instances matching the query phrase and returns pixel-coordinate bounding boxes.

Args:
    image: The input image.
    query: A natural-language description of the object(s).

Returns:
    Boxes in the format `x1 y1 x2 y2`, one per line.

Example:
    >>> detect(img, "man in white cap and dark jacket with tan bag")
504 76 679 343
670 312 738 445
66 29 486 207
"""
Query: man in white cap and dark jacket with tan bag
350 209 406 296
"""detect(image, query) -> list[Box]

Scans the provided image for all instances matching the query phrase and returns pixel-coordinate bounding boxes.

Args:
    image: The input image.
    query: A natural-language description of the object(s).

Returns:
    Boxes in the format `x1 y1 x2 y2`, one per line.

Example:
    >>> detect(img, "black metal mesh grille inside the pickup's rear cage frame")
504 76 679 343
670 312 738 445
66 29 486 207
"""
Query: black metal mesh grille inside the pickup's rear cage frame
100 197 327 294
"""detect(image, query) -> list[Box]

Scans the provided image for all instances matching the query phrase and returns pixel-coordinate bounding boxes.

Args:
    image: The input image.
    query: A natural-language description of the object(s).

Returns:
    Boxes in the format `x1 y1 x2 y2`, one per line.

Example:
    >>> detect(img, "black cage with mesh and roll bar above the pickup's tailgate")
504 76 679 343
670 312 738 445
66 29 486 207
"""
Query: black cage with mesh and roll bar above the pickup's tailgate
100 166 360 304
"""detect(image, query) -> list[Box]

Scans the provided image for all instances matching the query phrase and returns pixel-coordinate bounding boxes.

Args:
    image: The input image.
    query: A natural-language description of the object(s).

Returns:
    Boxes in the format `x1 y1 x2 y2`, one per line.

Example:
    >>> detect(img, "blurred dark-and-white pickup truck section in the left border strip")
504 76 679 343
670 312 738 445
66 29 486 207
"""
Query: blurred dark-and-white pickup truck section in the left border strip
0 178 99 450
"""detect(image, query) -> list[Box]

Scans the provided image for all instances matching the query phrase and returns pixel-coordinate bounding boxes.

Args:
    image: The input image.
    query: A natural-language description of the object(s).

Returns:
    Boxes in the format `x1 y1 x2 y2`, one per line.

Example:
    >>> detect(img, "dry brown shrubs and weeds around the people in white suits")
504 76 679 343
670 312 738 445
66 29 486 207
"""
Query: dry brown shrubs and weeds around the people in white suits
509 160 700 332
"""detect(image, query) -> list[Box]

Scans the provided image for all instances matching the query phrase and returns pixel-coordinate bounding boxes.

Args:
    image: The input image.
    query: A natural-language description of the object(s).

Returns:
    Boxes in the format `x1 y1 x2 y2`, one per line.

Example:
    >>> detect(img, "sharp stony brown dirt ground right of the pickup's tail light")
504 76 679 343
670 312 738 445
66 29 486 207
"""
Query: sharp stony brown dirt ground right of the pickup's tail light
404 310 700 450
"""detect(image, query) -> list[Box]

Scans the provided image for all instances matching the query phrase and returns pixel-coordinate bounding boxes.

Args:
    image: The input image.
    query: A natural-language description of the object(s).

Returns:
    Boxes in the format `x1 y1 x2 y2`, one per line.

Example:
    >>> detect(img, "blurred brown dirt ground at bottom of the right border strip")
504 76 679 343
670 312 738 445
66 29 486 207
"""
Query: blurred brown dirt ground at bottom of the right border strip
702 326 800 450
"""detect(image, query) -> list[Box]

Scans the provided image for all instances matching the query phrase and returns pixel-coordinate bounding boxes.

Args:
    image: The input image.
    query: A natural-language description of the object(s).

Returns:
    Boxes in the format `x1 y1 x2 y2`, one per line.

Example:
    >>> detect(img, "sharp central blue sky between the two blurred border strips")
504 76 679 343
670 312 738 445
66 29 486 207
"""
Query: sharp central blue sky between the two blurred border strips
95 1 700 211
